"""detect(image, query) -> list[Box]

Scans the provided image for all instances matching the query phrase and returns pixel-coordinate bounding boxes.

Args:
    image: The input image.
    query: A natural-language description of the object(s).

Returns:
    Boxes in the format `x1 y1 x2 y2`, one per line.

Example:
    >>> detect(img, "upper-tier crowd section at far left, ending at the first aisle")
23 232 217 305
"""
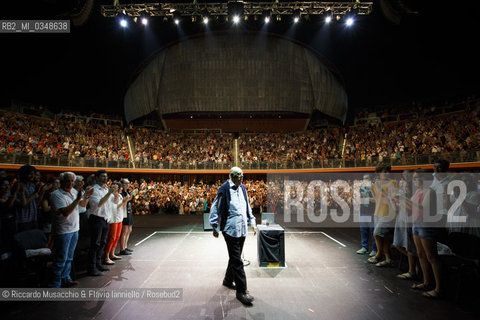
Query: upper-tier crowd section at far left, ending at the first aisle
0 112 130 160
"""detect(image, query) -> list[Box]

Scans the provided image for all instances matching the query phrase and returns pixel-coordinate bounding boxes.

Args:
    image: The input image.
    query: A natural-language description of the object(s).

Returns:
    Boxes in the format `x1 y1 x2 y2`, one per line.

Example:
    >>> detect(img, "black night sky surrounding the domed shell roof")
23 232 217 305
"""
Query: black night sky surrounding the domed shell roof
0 0 480 121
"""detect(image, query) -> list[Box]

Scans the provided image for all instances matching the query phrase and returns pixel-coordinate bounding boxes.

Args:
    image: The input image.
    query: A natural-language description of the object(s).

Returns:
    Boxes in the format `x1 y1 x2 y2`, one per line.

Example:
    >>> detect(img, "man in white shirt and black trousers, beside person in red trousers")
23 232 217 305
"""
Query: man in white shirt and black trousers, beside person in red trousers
88 170 114 276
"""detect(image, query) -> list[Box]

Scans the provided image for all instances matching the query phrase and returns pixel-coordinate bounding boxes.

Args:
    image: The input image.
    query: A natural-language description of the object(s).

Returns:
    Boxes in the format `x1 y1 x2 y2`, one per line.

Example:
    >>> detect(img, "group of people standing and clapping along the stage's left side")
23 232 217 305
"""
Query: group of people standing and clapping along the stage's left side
0 165 137 288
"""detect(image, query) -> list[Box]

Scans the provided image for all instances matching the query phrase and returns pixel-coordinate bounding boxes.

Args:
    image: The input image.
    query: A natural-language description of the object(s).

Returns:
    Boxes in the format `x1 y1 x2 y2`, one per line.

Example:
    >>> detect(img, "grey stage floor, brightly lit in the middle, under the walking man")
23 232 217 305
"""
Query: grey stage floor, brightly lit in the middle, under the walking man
2 216 479 320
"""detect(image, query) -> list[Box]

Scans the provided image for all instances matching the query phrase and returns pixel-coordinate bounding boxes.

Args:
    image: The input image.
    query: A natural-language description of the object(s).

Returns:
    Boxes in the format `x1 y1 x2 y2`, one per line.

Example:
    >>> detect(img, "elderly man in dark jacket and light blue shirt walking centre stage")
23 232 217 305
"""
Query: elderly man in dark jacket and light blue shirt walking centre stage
210 167 257 305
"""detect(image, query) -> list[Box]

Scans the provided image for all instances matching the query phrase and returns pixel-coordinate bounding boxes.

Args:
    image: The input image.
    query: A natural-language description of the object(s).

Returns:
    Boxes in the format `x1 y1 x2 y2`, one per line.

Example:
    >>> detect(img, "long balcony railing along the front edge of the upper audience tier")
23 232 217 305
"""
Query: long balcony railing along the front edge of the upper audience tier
0 150 480 170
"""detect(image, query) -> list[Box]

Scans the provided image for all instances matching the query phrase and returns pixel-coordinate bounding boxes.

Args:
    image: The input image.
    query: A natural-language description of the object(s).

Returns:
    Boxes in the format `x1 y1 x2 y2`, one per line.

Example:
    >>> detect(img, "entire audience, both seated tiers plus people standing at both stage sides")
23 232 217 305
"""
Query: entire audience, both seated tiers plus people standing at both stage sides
0 97 480 299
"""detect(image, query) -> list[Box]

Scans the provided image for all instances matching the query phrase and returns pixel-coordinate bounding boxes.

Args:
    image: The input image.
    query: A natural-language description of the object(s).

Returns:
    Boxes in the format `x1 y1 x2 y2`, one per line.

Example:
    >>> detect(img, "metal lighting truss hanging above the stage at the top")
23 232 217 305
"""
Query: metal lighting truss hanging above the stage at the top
101 0 373 18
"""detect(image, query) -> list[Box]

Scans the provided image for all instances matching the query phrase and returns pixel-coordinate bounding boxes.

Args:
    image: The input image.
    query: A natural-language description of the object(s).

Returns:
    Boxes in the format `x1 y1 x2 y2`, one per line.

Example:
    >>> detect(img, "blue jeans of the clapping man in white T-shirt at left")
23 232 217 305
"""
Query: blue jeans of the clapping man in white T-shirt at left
49 231 78 288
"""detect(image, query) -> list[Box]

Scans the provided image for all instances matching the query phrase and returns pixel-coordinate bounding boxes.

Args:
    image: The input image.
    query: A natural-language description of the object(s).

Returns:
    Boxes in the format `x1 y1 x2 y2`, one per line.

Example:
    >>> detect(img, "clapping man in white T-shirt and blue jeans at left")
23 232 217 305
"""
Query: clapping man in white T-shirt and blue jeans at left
49 172 93 288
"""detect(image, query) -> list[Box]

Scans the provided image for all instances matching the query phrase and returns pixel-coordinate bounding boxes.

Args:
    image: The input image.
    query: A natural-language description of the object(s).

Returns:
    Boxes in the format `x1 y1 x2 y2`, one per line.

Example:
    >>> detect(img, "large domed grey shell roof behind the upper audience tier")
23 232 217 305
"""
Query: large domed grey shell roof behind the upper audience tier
124 33 347 122
